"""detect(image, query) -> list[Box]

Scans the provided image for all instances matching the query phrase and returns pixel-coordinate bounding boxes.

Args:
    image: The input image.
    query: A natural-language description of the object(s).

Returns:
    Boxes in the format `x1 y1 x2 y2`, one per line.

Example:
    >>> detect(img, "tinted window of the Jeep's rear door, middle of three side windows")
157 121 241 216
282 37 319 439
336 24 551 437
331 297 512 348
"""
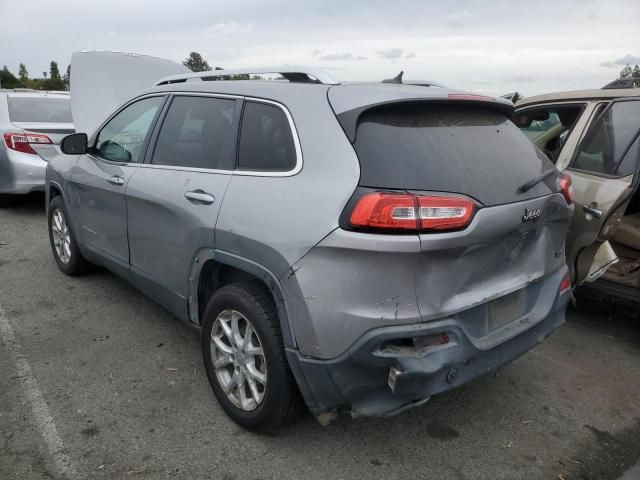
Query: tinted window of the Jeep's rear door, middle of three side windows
151 96 236 170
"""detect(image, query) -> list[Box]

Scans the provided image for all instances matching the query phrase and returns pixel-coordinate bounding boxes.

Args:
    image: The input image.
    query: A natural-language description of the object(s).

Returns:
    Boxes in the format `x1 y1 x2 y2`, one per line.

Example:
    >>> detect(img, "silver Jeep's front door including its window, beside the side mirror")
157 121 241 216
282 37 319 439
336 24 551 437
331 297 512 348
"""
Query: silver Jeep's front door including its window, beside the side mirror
69 96 165 274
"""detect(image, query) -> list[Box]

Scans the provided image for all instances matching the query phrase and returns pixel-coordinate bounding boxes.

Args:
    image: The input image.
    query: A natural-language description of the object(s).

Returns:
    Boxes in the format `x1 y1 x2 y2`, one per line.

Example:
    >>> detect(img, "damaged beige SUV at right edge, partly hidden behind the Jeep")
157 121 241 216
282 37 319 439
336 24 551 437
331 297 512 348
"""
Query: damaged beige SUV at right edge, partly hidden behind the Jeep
514 80 640 301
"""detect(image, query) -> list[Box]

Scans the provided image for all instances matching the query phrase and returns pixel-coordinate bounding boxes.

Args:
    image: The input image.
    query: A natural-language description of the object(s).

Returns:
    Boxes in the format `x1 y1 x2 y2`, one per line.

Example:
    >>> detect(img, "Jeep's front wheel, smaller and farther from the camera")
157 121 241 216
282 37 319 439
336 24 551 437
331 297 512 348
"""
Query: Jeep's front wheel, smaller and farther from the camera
48 196 91 276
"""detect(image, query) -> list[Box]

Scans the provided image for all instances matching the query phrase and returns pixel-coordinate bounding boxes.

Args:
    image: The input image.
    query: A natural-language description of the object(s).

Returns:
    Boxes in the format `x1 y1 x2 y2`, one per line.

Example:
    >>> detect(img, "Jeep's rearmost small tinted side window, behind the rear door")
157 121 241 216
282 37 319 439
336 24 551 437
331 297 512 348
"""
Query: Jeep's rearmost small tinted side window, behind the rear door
238 102 296 172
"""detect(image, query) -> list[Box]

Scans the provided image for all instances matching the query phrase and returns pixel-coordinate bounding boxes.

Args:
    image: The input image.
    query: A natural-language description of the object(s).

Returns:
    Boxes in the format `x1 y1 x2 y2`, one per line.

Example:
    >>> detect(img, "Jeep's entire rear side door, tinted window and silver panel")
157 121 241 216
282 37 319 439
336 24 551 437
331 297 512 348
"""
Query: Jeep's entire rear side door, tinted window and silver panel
126 94 242 318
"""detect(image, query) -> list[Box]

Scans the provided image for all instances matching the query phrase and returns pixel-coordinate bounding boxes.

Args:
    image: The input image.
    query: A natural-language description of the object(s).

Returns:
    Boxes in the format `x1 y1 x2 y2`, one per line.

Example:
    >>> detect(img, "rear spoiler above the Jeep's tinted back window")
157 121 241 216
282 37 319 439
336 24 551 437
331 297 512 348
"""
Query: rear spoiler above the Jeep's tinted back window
337 93 515 143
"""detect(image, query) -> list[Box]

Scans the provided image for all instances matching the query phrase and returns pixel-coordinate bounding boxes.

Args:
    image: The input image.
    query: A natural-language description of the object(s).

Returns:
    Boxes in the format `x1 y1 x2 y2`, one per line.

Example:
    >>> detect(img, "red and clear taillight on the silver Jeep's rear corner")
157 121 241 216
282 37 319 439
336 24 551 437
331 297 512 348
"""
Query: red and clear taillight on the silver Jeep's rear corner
350 192 476 231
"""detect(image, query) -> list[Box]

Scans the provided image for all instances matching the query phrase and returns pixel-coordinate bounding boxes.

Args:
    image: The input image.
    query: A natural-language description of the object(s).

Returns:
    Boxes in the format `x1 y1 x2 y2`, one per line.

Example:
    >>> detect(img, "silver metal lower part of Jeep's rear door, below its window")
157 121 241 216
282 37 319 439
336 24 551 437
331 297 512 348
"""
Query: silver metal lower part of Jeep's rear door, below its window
126 165 231 319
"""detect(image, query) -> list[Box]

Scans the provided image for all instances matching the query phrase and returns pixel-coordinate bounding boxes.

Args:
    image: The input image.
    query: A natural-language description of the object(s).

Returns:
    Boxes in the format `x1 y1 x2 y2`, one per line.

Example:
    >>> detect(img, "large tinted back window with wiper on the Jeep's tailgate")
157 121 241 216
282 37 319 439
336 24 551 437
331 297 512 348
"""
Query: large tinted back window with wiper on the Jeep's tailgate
354 103 556 205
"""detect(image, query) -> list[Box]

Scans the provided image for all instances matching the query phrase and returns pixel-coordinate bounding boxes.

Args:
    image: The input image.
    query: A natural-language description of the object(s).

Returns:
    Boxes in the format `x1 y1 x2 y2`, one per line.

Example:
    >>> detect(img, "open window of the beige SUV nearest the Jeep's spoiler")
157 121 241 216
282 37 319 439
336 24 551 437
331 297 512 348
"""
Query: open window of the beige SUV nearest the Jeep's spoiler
513 105 583 163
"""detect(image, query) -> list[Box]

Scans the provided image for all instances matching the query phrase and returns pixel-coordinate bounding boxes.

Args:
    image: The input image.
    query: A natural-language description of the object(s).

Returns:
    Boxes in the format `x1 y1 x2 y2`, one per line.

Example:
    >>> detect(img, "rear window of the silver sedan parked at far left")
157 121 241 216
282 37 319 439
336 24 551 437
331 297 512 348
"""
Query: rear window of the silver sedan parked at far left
7 97 73 123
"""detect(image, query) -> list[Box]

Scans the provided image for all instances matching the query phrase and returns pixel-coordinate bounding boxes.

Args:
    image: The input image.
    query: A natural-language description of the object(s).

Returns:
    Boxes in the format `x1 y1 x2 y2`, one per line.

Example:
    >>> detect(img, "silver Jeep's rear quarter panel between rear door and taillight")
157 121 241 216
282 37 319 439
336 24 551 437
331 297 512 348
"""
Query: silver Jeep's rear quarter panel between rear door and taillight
216 86 360 284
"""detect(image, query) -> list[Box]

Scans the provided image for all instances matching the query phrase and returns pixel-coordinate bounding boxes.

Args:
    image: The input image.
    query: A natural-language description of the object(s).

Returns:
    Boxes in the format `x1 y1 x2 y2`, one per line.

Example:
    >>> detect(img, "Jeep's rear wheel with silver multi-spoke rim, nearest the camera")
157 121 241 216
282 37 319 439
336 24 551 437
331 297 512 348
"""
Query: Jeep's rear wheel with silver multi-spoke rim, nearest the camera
202 283 303 433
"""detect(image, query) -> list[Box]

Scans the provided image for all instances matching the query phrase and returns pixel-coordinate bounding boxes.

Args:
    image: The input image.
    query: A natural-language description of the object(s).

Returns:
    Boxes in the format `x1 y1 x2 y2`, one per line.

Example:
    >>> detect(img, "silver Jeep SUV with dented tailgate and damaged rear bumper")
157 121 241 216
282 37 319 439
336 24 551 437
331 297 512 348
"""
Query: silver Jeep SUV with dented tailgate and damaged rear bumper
46 56 573 431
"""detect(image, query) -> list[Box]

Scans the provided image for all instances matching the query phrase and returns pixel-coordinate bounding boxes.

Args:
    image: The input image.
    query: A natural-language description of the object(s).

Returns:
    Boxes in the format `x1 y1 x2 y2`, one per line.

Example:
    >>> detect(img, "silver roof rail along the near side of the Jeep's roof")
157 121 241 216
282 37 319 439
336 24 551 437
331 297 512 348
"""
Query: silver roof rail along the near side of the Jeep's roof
154 65 340 87
